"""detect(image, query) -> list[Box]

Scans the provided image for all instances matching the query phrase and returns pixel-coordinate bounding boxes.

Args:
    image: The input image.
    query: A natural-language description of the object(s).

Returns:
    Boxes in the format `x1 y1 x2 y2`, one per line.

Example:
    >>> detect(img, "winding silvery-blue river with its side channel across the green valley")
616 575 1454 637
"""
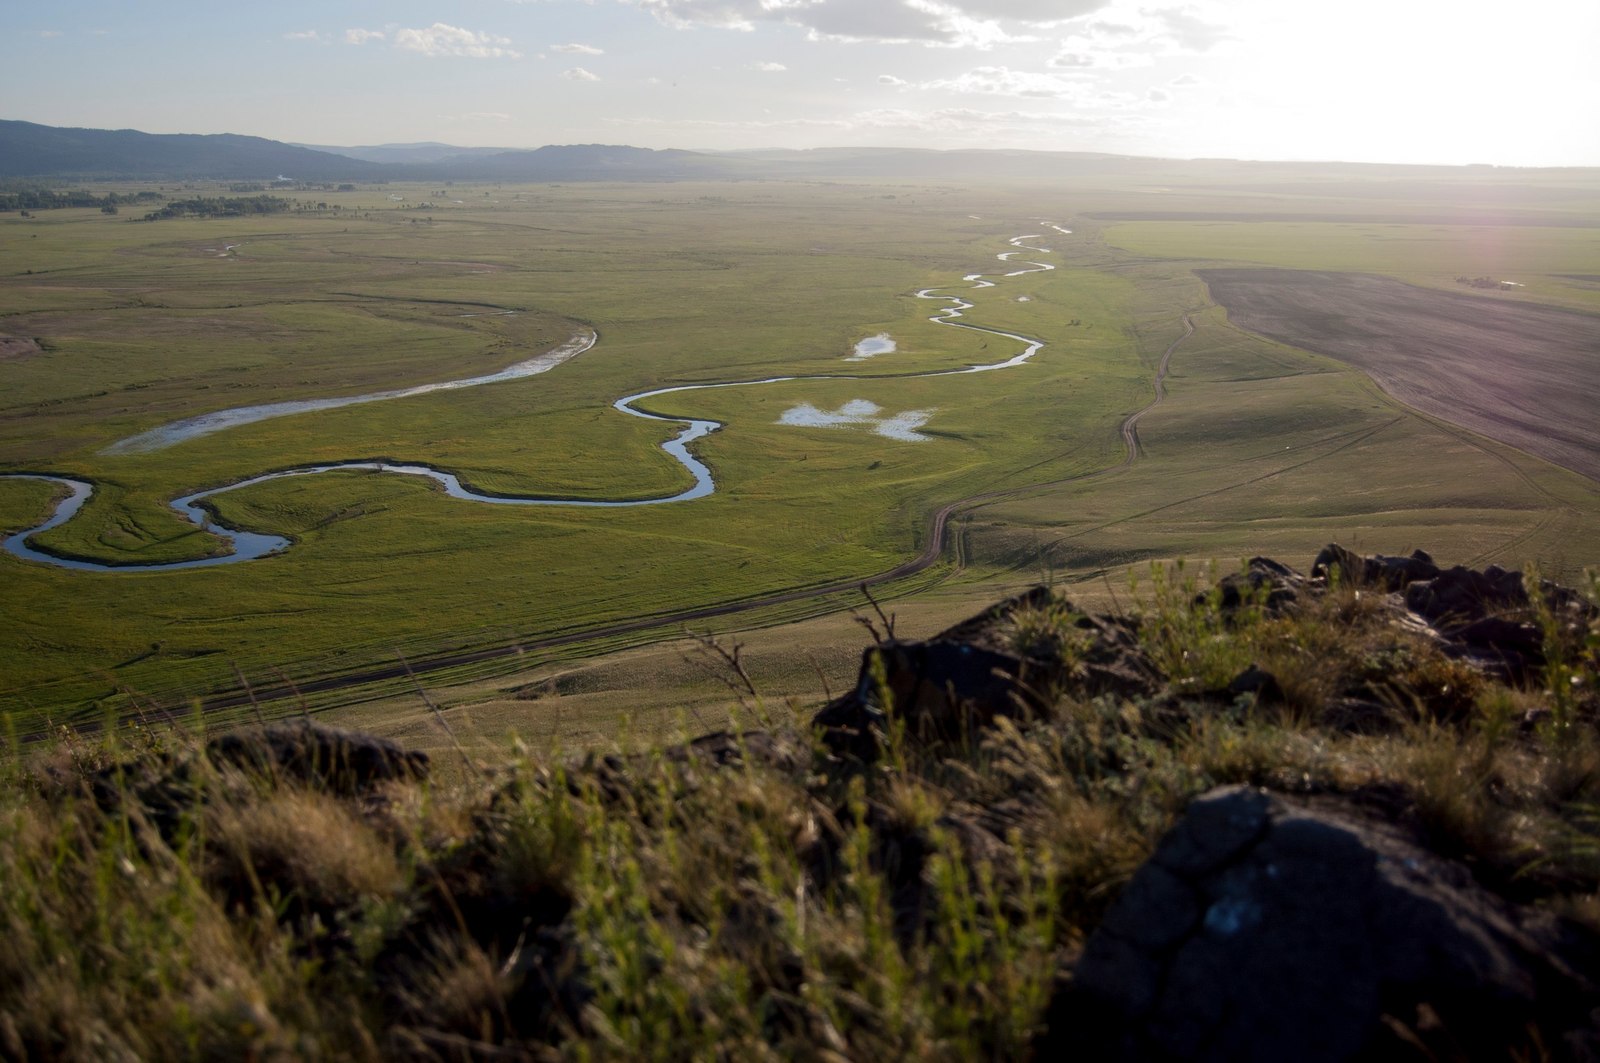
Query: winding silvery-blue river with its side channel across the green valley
12 223 1069 573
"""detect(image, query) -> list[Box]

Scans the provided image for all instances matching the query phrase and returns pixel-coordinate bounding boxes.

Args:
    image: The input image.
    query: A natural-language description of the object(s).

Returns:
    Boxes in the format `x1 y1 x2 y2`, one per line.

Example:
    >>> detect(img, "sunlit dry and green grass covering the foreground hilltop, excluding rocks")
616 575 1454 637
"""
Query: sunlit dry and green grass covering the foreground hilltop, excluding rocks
0 550 1600 1060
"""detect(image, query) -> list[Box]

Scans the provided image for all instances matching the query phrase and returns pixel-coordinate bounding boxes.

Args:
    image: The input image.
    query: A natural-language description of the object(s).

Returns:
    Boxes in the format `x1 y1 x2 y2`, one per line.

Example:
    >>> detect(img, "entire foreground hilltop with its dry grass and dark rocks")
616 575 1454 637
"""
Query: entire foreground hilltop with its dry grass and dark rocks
0 546 1600 1060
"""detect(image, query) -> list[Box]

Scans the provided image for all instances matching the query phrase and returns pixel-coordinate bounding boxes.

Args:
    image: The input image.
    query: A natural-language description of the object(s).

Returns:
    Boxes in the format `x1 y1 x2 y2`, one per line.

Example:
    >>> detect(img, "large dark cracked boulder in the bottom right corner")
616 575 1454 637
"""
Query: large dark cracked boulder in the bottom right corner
1042 788 1600 1061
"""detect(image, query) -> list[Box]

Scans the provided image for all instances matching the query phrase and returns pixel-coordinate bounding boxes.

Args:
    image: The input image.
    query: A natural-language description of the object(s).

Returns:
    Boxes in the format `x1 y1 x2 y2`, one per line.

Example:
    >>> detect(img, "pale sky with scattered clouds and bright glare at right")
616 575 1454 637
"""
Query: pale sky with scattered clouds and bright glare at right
0 0 1600 166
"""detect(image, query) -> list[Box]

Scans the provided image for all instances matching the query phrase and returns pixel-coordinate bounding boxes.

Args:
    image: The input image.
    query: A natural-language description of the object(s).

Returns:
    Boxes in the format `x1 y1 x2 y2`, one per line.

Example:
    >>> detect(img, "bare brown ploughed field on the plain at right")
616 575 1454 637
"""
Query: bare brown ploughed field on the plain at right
1195 269 1600 482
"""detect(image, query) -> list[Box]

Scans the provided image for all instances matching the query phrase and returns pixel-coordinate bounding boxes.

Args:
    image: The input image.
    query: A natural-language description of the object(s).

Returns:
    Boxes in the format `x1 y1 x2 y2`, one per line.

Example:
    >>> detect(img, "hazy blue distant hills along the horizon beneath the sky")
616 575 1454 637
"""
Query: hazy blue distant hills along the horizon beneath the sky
0 120 1594 188
